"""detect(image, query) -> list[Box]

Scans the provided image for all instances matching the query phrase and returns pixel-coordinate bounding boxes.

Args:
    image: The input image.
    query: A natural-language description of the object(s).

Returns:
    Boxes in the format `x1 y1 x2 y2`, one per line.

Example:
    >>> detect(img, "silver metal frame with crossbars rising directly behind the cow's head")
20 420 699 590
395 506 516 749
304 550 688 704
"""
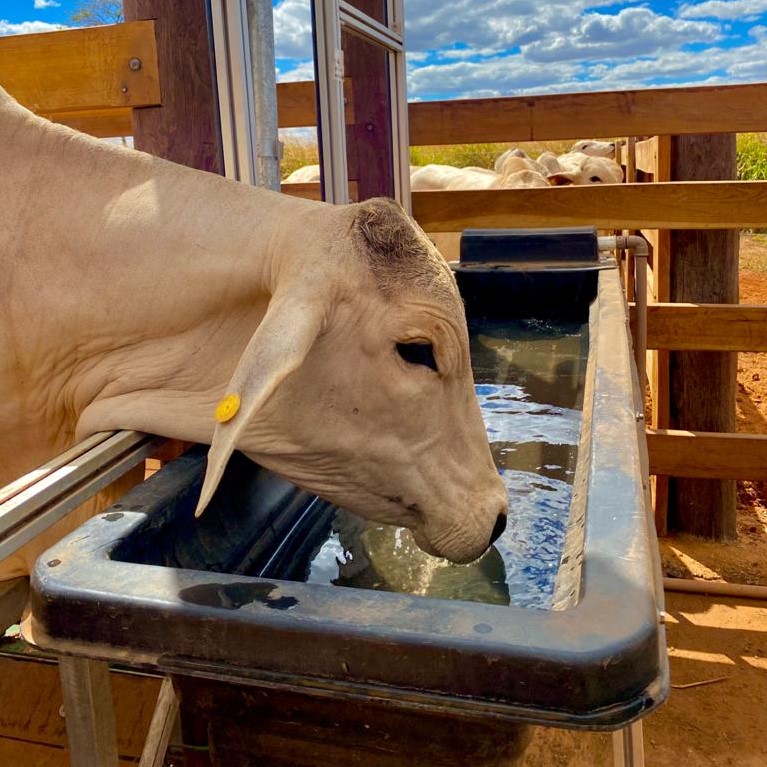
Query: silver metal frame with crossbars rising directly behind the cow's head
313 0 411 213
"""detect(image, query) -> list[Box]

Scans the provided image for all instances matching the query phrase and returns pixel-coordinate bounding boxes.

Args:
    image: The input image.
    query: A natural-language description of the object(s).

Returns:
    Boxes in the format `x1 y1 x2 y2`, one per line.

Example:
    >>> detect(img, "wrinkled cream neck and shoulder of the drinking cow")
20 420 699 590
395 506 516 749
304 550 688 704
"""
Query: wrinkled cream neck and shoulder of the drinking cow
0 89 349 484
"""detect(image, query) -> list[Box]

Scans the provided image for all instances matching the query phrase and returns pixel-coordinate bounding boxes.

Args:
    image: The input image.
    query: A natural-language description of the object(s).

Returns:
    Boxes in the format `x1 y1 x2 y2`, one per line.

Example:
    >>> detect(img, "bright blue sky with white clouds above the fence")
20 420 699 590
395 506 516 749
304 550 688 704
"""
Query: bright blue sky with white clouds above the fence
0 0 767 100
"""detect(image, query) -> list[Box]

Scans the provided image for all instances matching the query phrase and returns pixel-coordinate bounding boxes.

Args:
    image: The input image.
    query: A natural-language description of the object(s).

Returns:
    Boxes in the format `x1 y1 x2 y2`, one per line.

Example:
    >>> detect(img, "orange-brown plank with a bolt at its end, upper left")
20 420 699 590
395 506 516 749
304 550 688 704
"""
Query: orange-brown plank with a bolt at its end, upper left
0 21 160 115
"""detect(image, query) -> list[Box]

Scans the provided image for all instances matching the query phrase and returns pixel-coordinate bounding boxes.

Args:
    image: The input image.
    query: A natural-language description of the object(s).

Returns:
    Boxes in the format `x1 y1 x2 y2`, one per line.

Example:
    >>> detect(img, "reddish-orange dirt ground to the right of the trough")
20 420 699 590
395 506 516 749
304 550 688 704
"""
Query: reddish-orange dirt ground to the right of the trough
524 235 767 767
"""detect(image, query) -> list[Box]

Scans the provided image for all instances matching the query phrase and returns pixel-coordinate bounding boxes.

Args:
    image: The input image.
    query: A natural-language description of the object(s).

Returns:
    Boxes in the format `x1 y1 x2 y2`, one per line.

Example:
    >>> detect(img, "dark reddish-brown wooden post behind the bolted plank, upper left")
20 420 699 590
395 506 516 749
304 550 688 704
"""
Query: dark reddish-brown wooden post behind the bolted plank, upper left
123 0 223 173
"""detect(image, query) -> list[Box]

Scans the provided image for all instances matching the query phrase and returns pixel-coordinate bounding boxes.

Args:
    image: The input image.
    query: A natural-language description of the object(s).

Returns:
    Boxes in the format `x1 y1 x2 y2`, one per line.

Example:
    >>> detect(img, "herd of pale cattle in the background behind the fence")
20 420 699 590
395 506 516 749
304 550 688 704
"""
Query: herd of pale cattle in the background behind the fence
283 139 623 192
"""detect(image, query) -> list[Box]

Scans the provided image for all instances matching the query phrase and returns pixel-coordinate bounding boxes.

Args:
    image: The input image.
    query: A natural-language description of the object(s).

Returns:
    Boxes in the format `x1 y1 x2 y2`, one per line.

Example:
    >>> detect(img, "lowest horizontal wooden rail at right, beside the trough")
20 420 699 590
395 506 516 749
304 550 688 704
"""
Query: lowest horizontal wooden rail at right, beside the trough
647 429 767 480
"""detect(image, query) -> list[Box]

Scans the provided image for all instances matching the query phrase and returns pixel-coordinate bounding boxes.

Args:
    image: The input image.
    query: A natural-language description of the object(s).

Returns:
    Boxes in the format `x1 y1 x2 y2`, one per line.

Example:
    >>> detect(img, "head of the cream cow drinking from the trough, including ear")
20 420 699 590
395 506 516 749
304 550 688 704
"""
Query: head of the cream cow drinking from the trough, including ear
198 200 507 562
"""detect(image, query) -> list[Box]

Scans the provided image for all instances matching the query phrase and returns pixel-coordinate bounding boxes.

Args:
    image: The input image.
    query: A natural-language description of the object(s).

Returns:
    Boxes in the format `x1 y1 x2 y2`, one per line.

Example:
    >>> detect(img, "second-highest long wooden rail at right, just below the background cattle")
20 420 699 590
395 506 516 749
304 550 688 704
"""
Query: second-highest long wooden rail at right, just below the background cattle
413 181 767 232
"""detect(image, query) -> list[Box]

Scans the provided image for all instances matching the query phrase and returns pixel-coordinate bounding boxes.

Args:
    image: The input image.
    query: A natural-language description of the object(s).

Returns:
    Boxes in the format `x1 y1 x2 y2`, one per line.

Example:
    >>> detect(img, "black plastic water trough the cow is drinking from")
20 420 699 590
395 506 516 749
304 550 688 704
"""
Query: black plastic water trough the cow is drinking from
24 225 668 765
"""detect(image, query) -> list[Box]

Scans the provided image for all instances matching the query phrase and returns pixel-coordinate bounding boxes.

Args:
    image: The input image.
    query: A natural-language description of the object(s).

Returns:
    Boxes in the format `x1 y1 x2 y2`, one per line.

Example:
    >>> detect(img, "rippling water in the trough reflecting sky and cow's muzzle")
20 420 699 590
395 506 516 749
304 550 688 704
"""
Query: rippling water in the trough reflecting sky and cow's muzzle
306 321 588 609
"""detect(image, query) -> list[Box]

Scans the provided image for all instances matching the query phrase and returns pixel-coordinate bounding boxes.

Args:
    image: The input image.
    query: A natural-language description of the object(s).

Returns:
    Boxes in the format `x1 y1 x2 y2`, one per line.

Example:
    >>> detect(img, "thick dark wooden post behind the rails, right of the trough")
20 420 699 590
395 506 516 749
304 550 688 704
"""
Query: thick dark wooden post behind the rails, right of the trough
669 134 738 540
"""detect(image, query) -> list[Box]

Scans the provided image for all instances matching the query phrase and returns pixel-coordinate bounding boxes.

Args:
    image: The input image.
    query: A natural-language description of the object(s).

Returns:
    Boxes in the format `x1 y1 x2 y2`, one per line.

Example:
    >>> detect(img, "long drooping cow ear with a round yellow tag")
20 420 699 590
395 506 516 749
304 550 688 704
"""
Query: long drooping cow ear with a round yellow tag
195 296 323 517
